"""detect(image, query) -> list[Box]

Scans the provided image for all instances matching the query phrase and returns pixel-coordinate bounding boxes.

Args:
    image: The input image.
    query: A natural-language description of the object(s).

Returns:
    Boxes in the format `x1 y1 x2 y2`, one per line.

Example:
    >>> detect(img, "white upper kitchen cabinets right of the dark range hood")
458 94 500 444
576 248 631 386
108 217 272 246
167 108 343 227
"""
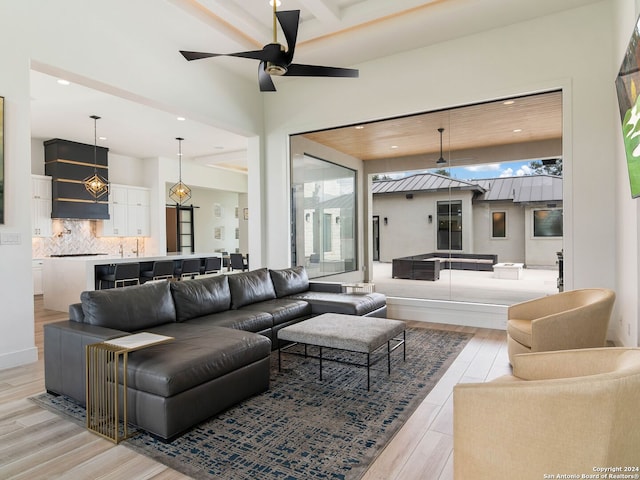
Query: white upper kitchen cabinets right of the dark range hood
98 184 151 237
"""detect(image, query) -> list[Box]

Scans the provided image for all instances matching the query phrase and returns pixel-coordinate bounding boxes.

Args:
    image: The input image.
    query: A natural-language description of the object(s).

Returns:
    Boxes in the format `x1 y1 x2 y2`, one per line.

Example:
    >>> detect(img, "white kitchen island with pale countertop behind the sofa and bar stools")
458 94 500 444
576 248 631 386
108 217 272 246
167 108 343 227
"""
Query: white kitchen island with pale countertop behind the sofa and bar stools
42 253 222 312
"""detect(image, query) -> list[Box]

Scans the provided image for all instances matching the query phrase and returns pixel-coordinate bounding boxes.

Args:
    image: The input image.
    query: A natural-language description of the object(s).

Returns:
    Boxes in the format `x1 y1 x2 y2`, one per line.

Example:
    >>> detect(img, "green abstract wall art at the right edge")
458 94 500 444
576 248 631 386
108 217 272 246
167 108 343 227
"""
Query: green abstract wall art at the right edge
616 18 640 198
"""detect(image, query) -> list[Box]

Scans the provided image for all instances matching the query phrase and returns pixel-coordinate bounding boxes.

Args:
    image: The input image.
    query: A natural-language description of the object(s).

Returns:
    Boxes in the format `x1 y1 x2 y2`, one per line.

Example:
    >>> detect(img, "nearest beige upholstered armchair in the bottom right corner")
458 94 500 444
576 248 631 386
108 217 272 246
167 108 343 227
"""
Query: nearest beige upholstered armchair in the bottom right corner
453 348 640 480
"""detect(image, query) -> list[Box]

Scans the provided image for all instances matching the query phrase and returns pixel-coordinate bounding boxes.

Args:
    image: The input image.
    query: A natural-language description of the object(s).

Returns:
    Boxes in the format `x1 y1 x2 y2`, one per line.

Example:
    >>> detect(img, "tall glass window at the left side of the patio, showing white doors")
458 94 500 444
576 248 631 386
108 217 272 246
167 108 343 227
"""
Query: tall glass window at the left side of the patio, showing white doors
291 155 357 278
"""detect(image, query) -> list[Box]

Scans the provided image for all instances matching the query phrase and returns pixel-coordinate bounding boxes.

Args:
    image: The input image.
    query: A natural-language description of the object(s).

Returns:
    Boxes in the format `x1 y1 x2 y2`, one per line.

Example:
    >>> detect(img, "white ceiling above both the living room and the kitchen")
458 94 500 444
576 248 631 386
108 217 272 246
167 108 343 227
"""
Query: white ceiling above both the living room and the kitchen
31 0 597 166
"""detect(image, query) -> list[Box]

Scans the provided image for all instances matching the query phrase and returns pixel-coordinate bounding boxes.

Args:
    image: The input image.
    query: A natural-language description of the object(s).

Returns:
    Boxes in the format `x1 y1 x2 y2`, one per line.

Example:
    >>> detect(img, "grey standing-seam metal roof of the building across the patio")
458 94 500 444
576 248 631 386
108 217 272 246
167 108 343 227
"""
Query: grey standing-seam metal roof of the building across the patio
371 173 562 203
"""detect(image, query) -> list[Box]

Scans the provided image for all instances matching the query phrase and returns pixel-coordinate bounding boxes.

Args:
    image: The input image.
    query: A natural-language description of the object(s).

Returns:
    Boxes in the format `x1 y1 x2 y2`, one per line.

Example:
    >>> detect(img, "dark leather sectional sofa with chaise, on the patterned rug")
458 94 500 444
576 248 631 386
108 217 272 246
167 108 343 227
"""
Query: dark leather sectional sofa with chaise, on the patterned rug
44 267 386 440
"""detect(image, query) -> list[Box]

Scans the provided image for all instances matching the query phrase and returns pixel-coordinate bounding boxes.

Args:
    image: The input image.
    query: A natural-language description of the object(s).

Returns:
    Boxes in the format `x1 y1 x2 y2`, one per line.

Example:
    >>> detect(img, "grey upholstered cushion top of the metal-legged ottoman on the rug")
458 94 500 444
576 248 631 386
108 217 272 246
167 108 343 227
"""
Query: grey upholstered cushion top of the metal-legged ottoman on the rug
278 313 405 353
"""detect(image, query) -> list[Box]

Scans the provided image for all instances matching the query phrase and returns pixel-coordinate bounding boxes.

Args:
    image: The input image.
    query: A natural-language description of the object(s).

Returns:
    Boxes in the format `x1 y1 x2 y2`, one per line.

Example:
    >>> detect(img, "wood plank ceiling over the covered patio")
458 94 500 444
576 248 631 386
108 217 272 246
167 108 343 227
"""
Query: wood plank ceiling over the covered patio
303 91 562 163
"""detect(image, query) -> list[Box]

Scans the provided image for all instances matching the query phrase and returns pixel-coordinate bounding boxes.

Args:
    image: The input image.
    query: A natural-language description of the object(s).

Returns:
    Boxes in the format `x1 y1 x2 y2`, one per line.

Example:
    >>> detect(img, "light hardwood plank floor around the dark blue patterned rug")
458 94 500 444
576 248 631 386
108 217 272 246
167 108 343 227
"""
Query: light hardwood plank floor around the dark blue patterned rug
0 296 510 480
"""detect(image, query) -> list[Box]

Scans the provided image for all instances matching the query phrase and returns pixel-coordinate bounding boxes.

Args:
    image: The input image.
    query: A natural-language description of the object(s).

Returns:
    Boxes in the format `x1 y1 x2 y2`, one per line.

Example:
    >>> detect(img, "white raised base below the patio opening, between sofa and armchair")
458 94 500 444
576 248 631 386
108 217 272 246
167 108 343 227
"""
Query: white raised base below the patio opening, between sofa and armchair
387 297 509 330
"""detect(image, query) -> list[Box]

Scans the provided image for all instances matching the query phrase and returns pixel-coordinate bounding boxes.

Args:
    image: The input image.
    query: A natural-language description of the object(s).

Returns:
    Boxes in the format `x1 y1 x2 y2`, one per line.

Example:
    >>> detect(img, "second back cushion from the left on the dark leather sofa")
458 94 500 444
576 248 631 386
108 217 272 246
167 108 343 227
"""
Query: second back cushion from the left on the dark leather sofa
171 275 231 322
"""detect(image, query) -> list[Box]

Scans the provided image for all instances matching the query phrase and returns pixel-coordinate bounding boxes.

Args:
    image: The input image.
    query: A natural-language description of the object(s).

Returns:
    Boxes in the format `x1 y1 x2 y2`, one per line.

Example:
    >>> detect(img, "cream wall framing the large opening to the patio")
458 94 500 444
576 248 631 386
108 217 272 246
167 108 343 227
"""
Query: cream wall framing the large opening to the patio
265 1 639 344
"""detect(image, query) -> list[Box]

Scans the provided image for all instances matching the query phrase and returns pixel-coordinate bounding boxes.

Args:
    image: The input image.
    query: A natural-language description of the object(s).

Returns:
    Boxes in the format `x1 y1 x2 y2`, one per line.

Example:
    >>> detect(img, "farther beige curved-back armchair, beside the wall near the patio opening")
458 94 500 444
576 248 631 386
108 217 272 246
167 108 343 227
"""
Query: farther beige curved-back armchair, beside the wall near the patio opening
507 288 616 364
